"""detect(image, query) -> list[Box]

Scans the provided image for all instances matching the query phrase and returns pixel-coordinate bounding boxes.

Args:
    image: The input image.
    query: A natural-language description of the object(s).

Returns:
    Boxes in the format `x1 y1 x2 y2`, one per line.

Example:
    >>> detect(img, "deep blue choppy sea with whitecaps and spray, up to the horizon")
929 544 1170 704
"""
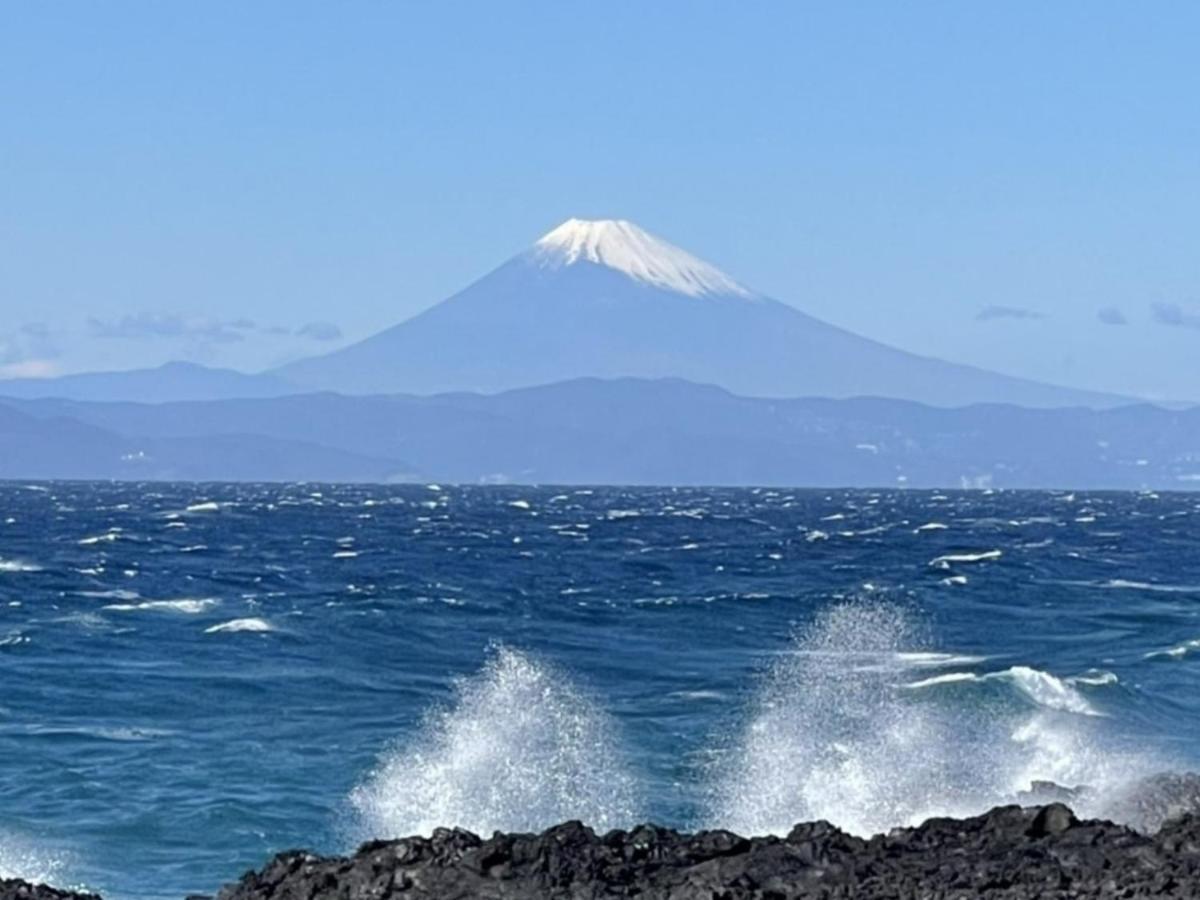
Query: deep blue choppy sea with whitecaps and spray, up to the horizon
0 484 1200 898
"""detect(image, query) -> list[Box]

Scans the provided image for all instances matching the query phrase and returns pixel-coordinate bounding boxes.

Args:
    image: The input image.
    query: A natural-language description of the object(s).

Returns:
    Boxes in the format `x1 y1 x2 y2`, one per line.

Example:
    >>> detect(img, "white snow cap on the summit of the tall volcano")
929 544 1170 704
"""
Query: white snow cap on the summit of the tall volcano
532 218 754 298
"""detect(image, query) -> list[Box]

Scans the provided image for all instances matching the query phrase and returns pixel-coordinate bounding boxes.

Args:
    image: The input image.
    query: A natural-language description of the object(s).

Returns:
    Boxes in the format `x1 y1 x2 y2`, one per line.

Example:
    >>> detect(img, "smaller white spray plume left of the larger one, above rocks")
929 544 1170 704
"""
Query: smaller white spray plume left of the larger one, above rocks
350 647 640 836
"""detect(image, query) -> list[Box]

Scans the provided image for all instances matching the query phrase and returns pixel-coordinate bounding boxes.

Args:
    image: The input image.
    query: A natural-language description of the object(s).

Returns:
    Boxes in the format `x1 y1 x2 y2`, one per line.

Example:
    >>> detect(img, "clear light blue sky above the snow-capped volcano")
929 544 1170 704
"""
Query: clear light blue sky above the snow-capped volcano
0 1 1200 400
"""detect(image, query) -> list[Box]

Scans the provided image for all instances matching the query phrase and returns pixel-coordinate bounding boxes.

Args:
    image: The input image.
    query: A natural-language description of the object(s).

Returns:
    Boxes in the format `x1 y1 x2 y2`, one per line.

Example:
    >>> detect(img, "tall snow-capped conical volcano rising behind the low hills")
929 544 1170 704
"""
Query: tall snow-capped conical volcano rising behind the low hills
271 218 1123 407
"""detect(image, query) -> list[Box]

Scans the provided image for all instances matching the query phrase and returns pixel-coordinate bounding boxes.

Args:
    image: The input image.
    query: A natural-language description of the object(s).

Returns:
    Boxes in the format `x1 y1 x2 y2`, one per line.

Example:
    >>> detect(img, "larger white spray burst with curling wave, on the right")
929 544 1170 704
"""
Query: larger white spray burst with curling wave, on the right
707 602 1153 835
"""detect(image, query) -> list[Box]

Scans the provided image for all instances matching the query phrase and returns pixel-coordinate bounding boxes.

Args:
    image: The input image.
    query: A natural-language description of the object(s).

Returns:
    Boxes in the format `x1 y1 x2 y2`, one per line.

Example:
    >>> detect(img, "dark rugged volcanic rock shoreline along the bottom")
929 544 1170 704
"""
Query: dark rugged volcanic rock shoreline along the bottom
7 803 1200 900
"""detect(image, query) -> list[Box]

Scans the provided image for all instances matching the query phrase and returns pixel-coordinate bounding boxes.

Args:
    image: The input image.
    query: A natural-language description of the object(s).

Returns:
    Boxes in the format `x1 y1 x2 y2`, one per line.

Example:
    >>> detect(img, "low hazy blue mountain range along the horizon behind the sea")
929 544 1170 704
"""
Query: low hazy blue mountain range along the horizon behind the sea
0 379 1200 488
